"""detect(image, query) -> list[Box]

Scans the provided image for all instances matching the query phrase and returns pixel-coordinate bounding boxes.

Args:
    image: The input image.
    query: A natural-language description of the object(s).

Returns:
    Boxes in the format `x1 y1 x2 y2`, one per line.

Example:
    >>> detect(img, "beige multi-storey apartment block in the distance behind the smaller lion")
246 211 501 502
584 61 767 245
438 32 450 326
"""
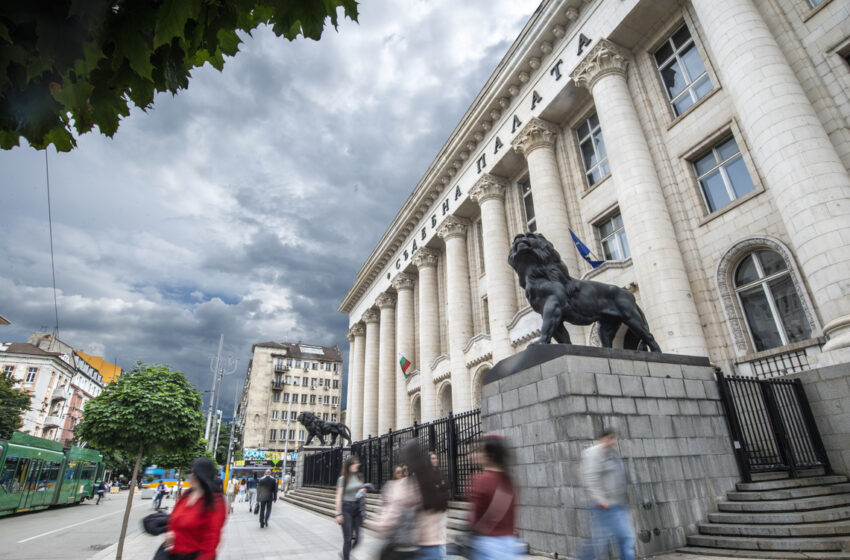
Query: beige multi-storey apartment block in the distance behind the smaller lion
237 342 342 464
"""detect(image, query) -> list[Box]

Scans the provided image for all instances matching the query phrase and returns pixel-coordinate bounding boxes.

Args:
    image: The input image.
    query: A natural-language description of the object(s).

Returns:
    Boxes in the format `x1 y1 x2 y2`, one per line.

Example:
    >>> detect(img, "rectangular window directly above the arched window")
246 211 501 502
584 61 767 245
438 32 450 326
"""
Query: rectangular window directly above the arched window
694 138 755 212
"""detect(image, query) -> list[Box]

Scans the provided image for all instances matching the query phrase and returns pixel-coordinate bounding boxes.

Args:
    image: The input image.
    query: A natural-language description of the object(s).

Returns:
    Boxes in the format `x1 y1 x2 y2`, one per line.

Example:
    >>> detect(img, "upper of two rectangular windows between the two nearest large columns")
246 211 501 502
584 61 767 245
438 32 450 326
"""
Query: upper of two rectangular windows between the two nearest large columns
654 25 712 117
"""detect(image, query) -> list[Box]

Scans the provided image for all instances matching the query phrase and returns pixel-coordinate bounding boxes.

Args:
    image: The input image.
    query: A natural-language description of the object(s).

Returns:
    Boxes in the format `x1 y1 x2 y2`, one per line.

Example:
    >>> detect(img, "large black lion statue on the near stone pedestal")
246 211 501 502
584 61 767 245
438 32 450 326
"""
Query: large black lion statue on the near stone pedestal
508 233 661 352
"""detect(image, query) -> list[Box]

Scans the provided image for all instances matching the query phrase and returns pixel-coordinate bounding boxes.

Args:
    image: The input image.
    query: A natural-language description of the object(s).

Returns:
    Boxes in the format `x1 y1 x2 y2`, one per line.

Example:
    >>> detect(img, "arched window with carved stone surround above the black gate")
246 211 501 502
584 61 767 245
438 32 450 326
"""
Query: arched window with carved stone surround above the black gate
734 249 812 352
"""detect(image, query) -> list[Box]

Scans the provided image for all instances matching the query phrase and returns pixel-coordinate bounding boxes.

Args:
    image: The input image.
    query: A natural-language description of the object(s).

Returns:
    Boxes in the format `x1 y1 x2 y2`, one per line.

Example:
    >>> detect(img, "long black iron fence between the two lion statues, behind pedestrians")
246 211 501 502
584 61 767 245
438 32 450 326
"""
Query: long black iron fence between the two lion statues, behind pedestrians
304 410 481 499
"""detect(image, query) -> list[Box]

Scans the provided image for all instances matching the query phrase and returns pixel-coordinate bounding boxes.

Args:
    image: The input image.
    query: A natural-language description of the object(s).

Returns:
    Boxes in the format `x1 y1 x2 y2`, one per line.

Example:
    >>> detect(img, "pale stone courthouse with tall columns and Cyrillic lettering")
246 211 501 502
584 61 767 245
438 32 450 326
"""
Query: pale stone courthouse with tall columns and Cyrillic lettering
339 0 850 438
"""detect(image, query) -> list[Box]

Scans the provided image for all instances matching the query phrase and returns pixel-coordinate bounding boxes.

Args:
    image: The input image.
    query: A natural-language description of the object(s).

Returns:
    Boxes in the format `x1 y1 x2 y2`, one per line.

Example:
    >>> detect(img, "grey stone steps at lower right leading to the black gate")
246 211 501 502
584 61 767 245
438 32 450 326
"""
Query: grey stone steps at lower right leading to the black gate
680 475 850 560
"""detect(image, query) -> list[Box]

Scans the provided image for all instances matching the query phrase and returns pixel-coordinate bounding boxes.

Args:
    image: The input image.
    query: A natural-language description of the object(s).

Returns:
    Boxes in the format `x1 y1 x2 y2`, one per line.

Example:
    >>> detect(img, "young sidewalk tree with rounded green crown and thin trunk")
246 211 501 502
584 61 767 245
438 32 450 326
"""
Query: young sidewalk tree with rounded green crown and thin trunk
74 362 204 560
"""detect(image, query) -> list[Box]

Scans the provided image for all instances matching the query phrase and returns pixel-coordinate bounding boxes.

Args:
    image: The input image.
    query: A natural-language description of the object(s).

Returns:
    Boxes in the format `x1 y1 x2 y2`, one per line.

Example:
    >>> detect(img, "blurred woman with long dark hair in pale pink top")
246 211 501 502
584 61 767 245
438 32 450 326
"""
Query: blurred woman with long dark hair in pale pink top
373 440 449 560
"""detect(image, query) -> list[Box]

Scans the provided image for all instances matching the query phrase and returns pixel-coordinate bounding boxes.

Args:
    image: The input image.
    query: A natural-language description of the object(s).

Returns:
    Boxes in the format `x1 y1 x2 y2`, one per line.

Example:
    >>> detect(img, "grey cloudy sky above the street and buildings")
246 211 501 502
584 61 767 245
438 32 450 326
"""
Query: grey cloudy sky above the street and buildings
0 0 539 416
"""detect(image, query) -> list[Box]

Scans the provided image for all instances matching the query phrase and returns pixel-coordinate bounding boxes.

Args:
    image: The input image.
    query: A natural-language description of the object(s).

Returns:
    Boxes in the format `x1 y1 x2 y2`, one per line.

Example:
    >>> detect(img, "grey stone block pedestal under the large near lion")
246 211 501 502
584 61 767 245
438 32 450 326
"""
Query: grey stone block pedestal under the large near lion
481 344 739 557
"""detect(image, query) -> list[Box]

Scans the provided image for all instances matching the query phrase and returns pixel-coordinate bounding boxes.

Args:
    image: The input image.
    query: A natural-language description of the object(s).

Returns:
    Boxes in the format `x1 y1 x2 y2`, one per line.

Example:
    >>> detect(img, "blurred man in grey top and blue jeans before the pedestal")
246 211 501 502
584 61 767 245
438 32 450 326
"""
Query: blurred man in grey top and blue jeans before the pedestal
581 430 637 560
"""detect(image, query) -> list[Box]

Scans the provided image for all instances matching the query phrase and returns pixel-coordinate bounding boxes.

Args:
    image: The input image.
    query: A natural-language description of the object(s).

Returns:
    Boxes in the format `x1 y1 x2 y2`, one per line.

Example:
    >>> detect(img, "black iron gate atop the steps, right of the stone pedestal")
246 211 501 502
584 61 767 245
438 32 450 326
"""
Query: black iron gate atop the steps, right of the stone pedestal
717 370 831 482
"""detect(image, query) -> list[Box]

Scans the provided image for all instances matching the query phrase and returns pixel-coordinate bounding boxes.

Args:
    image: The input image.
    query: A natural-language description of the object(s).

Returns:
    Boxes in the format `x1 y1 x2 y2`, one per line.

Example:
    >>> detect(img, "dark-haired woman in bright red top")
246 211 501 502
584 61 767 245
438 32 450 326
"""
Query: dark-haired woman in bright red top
163 457 227 560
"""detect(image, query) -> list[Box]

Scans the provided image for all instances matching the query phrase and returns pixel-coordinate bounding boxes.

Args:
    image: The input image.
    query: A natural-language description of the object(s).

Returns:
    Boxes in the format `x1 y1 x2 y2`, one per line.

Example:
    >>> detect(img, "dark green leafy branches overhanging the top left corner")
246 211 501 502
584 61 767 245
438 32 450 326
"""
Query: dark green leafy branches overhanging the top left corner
0 0 358 151
